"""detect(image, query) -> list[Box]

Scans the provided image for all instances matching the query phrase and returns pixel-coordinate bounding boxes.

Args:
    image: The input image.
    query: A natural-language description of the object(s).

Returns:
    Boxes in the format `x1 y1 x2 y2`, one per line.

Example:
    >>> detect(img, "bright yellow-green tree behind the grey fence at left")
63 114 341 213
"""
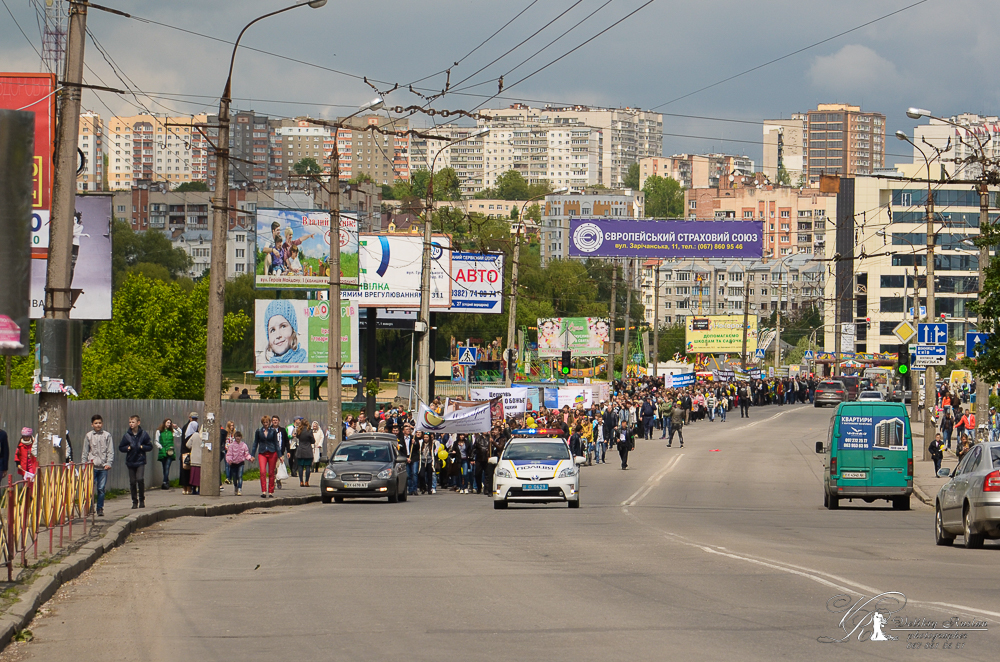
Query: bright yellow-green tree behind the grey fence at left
81 274 250 400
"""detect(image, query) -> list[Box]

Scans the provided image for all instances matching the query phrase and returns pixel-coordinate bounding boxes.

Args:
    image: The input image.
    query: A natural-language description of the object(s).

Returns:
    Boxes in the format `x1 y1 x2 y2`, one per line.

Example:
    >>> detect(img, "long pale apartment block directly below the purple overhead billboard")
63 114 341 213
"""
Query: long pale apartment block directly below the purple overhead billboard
640 255 826 326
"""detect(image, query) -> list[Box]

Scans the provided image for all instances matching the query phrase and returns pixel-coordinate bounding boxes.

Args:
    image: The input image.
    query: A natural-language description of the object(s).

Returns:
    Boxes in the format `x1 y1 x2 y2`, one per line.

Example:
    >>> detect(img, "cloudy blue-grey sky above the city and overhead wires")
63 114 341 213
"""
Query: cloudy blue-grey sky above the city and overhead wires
0 0 1000 164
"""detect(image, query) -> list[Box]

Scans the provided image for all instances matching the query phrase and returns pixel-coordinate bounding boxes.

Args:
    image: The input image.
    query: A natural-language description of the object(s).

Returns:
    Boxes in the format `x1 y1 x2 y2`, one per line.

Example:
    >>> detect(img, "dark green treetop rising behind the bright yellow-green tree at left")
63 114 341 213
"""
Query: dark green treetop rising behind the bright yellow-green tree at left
111 219 192 290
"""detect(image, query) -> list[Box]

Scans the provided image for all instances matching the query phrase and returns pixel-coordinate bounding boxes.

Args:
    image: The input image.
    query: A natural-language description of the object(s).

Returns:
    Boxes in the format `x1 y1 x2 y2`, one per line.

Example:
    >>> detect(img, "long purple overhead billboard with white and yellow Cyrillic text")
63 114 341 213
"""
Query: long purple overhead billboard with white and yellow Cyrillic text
569 218 764 259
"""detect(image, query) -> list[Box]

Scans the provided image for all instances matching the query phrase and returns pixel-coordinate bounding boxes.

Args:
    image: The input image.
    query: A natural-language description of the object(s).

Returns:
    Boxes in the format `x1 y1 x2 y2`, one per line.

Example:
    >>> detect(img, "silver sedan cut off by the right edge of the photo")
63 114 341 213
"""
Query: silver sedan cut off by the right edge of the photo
934 443 1000 549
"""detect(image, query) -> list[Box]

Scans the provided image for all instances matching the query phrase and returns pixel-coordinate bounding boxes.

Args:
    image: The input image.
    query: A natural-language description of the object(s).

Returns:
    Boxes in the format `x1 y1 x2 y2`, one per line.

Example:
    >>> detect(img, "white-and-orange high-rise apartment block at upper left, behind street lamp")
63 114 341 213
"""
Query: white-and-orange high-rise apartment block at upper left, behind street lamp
104 115 209 191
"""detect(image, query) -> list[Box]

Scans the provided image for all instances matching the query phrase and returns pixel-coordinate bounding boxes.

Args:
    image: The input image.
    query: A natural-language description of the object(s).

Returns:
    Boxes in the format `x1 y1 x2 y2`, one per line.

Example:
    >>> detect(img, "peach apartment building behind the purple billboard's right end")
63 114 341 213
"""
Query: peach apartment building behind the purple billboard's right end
684 187 837 258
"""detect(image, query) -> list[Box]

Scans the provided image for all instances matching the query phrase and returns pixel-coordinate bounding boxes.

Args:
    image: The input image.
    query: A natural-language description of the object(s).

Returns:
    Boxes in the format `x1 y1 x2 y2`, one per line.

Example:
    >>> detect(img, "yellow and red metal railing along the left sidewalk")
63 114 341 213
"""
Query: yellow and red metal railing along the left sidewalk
0 464 94 581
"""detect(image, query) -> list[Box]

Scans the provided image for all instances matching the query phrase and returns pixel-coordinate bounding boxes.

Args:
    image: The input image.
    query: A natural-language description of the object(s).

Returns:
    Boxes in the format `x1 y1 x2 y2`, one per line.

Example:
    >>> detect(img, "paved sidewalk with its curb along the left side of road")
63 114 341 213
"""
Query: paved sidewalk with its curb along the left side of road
0 472 320 650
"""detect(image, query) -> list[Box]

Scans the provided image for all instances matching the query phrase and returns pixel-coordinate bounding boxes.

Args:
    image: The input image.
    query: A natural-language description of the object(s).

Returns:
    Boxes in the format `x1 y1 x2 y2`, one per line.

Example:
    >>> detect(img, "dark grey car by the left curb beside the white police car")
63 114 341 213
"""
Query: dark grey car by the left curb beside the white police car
319 432 406 503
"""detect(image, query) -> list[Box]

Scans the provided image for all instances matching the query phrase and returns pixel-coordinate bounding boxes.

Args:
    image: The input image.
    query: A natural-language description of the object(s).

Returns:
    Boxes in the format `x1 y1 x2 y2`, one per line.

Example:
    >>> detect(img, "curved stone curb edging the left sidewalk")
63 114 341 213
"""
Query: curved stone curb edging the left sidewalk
0 494 320 651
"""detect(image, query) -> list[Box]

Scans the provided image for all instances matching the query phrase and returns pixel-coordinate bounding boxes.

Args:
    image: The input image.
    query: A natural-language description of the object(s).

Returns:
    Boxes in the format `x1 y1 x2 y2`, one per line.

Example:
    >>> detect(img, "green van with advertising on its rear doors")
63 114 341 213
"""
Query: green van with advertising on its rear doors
816 402 913 510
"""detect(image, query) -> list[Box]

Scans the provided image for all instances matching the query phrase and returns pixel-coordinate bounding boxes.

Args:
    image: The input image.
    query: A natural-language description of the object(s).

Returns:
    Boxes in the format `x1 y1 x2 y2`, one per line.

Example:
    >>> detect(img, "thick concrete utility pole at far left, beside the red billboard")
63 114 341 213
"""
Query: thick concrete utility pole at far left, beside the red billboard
36 2 87 465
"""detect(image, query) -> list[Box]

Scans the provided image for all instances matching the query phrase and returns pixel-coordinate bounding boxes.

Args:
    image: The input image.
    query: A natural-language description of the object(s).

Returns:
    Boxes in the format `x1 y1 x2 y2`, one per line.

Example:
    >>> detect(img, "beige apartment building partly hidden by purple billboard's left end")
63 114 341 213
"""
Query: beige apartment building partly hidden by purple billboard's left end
541 189 646 264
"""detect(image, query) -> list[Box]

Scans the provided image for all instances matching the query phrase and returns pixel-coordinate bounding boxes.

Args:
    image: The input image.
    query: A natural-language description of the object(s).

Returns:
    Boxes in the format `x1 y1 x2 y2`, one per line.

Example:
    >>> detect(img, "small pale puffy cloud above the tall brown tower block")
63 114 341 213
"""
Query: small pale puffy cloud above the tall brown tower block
809 44 900 96
